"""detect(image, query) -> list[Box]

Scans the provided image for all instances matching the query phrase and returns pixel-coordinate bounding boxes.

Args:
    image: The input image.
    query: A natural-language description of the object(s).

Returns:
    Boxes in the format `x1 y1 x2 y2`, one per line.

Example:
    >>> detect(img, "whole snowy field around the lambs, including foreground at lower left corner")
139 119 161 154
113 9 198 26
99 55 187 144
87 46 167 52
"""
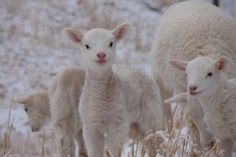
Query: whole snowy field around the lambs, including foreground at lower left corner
0 0 236 157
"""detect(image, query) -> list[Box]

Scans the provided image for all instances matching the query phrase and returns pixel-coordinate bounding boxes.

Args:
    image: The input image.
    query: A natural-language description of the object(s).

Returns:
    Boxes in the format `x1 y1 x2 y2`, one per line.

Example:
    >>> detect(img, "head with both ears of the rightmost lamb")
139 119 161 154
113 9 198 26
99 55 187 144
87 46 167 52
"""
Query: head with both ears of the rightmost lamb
168 56 229 96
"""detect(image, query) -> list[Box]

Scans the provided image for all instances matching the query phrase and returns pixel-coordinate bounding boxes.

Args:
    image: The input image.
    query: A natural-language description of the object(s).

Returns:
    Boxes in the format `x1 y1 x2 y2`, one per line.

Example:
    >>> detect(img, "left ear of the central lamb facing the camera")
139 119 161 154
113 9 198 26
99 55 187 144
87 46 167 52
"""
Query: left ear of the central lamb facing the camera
64 28 84 43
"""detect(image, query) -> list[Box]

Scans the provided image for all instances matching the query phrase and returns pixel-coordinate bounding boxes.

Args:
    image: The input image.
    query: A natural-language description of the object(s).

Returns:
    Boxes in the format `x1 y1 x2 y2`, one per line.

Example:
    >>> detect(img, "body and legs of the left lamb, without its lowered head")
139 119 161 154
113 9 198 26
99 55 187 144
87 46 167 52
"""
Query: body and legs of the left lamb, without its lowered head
49 67 87 156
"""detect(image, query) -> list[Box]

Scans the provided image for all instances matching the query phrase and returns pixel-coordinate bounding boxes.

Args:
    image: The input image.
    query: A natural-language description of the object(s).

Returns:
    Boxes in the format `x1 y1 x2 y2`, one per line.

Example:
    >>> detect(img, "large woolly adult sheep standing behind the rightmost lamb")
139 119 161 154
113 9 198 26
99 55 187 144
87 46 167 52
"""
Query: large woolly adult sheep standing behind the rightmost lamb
151 1 236 147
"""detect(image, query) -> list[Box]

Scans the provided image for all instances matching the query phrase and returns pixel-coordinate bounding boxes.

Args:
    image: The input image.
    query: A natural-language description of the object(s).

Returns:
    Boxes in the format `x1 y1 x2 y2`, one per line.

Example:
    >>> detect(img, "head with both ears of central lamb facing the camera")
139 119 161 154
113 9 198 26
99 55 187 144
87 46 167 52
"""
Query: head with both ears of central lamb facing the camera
65 23 129 70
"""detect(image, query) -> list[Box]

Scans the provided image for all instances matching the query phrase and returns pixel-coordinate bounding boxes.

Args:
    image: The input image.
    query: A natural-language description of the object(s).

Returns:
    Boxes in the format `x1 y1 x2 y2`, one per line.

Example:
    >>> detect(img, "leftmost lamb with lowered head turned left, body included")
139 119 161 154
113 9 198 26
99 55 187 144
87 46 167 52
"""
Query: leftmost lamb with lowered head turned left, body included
15 67 87 157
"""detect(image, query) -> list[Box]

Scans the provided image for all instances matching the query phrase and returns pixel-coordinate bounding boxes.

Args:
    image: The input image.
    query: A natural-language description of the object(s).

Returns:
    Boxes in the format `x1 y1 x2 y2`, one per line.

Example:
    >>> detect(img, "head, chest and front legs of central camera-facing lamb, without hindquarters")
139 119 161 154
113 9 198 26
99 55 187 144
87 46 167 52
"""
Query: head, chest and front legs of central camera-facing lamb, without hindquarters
65 24 129 157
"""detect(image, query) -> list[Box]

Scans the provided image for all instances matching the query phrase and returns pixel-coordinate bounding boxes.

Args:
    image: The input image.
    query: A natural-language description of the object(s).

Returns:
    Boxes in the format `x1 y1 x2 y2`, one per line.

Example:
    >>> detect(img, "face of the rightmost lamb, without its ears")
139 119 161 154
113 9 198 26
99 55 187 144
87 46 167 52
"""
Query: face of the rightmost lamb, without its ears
186 57 221 96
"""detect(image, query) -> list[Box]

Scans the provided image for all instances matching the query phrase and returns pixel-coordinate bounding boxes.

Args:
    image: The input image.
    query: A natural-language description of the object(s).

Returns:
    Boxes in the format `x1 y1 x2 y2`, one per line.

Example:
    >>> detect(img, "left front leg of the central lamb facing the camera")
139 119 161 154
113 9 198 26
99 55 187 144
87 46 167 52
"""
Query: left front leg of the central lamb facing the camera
83 125 105 157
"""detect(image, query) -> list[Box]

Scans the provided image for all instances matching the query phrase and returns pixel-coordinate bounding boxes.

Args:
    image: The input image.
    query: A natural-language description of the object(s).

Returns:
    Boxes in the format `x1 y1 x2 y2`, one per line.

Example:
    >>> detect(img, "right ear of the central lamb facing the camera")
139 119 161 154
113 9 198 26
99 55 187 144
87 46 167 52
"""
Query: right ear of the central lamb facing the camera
111 23 129 41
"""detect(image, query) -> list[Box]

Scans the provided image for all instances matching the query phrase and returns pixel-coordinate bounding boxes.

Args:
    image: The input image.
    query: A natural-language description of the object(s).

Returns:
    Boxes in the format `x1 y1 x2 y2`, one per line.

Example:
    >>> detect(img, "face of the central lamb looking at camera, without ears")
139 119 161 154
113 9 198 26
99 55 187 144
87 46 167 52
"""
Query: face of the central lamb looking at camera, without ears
80 29 116 70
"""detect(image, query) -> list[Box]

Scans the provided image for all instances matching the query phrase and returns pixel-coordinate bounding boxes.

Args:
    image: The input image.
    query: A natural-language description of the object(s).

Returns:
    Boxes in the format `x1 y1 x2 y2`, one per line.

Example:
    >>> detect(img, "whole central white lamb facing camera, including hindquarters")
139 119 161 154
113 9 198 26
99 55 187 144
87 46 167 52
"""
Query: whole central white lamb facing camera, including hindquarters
65 24 162 157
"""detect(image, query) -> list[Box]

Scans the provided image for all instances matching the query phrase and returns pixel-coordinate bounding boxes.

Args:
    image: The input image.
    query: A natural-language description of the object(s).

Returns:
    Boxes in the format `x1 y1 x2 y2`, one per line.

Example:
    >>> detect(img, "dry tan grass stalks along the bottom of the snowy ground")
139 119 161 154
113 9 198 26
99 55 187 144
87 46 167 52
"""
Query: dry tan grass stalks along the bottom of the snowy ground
0 95 225 157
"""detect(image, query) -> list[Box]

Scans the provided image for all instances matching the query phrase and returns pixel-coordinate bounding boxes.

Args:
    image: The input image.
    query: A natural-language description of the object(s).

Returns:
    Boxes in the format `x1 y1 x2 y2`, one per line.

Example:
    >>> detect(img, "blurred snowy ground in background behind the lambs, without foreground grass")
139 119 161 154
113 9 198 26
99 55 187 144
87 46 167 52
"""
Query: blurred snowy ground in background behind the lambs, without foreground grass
0 0 160 132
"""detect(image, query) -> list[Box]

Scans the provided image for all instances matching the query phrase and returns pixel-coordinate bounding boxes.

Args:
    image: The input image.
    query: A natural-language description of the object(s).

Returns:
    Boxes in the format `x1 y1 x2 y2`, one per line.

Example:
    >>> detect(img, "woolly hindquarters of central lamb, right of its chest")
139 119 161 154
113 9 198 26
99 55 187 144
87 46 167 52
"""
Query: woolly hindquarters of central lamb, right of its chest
115 65 164 156
